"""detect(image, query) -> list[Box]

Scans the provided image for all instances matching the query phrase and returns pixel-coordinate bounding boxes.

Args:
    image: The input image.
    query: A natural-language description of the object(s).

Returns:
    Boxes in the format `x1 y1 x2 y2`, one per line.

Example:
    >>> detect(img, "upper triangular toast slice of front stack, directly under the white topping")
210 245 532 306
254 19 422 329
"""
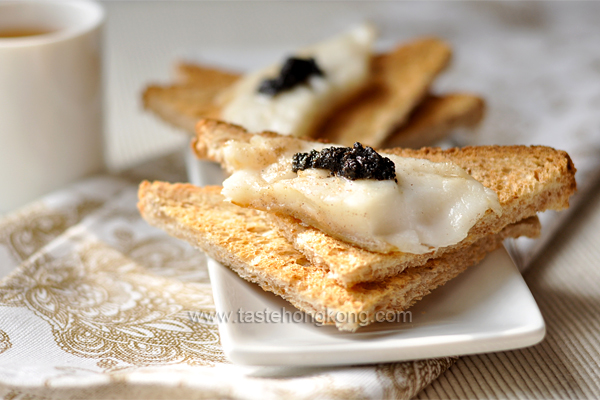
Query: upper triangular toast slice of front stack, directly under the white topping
192 120 576 286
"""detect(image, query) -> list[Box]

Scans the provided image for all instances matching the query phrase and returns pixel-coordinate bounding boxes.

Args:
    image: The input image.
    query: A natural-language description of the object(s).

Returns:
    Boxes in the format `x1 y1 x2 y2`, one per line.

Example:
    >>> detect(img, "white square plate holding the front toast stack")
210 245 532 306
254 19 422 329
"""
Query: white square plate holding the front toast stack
187 152 546 366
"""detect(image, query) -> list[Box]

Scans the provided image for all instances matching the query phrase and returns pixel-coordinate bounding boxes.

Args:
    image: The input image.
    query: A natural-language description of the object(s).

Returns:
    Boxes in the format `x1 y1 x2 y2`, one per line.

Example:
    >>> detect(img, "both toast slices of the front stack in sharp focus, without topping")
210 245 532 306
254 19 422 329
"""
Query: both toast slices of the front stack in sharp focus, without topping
139 120 576 331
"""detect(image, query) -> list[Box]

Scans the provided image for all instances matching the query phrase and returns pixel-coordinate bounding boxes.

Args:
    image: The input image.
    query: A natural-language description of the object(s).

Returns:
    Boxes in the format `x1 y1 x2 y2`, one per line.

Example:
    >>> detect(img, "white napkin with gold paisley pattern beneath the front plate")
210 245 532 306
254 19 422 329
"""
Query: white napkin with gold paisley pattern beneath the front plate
0 155 454 399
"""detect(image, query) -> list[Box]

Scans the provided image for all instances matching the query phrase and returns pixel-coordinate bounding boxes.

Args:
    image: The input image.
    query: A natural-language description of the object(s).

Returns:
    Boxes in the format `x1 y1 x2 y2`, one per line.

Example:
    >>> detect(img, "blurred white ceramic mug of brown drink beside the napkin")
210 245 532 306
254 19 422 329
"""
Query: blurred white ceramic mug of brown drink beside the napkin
0 0 104 214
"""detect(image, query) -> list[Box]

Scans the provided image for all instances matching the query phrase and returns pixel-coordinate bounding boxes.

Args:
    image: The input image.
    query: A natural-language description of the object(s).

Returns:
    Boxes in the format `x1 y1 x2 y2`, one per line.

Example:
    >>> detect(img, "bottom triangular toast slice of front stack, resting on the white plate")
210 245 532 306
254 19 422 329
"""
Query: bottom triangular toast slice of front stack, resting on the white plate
138 182 539 331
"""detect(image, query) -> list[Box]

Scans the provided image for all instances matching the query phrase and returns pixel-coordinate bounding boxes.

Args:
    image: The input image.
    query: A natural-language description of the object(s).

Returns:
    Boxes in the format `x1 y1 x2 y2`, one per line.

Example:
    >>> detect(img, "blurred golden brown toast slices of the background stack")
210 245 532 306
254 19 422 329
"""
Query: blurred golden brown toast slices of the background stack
143 38 483 146
